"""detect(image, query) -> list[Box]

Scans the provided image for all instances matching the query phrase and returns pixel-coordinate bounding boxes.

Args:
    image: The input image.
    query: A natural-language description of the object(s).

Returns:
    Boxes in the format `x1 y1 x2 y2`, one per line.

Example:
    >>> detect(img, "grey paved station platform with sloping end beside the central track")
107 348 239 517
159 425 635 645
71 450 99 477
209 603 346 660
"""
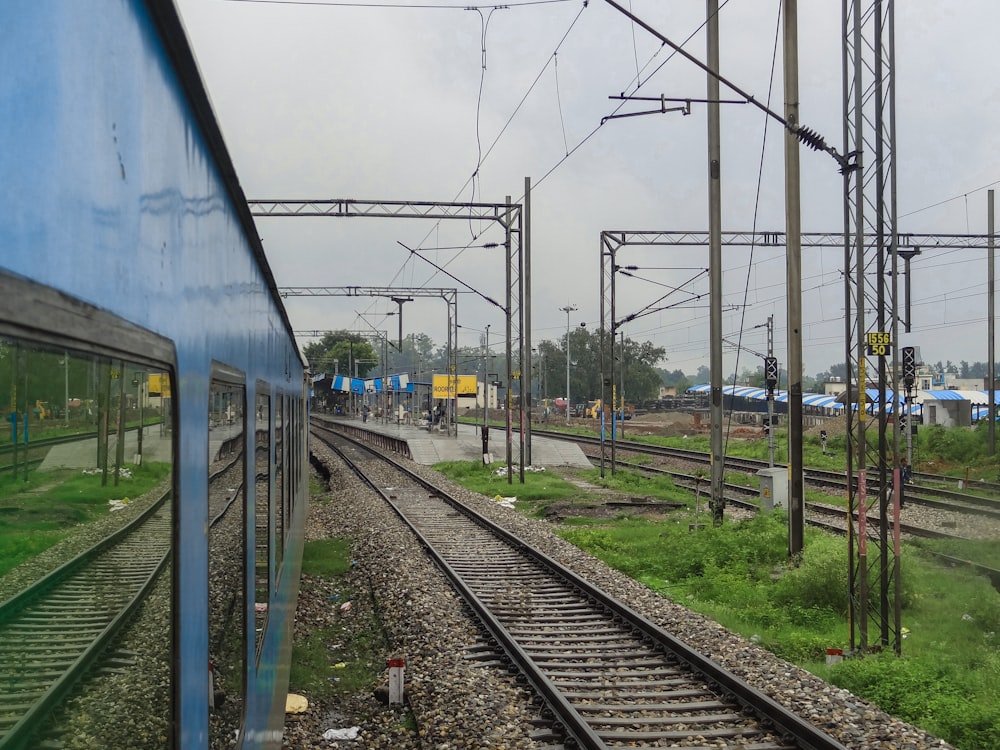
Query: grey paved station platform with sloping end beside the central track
313 414 591 469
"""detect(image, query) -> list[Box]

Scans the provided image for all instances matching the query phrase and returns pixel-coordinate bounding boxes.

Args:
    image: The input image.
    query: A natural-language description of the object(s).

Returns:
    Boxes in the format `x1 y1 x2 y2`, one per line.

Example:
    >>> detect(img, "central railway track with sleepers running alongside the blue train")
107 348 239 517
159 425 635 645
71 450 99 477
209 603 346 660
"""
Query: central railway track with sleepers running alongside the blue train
313 429 843 750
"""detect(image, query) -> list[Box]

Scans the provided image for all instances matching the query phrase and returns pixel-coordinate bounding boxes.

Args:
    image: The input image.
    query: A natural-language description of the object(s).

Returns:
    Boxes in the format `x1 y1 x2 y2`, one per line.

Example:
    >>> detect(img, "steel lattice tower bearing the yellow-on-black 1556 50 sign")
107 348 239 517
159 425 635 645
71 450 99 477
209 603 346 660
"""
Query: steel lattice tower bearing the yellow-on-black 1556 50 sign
843 0 900 652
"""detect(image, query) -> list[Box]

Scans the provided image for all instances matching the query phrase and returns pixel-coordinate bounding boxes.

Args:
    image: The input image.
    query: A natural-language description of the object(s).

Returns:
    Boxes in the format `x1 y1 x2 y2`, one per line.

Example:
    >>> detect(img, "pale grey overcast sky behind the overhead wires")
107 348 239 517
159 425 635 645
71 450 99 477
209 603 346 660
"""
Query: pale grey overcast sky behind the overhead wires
177 0 1000 380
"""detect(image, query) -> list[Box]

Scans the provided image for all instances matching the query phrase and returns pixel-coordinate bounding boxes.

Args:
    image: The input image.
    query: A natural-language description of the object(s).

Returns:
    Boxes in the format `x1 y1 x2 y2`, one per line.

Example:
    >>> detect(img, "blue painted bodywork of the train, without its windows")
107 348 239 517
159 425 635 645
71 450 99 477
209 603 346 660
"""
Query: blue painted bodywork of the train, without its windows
0 0 306 748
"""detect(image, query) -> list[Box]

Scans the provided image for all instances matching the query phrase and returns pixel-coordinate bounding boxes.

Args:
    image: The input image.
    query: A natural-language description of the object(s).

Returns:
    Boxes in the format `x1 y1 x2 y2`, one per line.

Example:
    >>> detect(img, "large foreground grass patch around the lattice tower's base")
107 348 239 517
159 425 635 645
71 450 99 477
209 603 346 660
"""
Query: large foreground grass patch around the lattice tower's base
559 513 1000 750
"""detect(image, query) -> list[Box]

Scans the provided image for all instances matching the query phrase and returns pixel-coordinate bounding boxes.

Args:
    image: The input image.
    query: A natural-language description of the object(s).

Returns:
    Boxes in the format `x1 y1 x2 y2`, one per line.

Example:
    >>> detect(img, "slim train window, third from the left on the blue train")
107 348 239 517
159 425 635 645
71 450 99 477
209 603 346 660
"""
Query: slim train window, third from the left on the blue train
253 388 271 656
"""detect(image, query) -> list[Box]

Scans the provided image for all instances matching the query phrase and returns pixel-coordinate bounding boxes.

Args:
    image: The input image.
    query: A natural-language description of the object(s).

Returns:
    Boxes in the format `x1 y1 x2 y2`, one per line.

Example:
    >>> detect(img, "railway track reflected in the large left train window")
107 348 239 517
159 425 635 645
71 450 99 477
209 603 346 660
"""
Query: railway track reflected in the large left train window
0 491 172 750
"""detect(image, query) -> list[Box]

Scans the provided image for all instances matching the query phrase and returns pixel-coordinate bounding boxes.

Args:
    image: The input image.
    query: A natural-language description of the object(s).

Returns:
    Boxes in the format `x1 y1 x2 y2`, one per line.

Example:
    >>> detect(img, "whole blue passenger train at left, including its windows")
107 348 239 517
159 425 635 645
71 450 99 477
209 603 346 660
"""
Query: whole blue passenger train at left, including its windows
0 0 309 750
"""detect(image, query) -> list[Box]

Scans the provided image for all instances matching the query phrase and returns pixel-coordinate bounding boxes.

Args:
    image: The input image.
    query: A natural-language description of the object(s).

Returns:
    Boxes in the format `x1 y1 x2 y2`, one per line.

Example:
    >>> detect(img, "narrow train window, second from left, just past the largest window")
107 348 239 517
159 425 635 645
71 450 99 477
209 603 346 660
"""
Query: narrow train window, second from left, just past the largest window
208 364 246 750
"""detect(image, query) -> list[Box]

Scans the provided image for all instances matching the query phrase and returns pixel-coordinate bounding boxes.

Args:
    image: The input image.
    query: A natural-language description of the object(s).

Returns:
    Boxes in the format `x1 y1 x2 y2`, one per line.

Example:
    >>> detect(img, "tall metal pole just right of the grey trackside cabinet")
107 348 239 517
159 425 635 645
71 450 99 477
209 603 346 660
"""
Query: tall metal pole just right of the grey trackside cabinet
784 0 804 557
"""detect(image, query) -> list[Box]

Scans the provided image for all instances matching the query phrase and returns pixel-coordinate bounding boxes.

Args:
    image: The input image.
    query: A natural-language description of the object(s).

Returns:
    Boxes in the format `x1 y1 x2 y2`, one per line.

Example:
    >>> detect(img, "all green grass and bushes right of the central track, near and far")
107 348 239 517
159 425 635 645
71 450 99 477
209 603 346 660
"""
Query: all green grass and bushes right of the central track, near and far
435 427 1000 750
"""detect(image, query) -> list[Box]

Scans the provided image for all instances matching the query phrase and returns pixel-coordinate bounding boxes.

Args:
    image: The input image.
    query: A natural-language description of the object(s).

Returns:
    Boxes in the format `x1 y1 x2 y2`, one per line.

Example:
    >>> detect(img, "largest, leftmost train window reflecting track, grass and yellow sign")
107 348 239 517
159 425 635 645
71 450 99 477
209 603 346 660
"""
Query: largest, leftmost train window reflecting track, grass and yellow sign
0 336 175 748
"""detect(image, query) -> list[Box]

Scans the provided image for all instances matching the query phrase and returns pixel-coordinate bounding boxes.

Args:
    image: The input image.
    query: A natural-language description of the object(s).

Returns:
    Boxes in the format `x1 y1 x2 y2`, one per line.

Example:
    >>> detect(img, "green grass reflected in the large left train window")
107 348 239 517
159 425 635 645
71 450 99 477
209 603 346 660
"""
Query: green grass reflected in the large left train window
0 462 172 575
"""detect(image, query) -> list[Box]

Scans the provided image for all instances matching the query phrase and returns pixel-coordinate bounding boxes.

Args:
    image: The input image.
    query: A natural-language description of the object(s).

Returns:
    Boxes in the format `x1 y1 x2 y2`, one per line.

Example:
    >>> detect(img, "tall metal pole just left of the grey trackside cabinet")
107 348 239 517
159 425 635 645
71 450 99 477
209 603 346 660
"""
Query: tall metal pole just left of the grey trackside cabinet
706 0 726 525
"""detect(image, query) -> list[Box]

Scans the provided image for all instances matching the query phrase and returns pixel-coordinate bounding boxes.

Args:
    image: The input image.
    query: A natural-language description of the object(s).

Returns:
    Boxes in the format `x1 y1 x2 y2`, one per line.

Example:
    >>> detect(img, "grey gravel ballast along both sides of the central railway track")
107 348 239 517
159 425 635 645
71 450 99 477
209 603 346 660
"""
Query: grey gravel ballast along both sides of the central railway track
284 440 952 750
